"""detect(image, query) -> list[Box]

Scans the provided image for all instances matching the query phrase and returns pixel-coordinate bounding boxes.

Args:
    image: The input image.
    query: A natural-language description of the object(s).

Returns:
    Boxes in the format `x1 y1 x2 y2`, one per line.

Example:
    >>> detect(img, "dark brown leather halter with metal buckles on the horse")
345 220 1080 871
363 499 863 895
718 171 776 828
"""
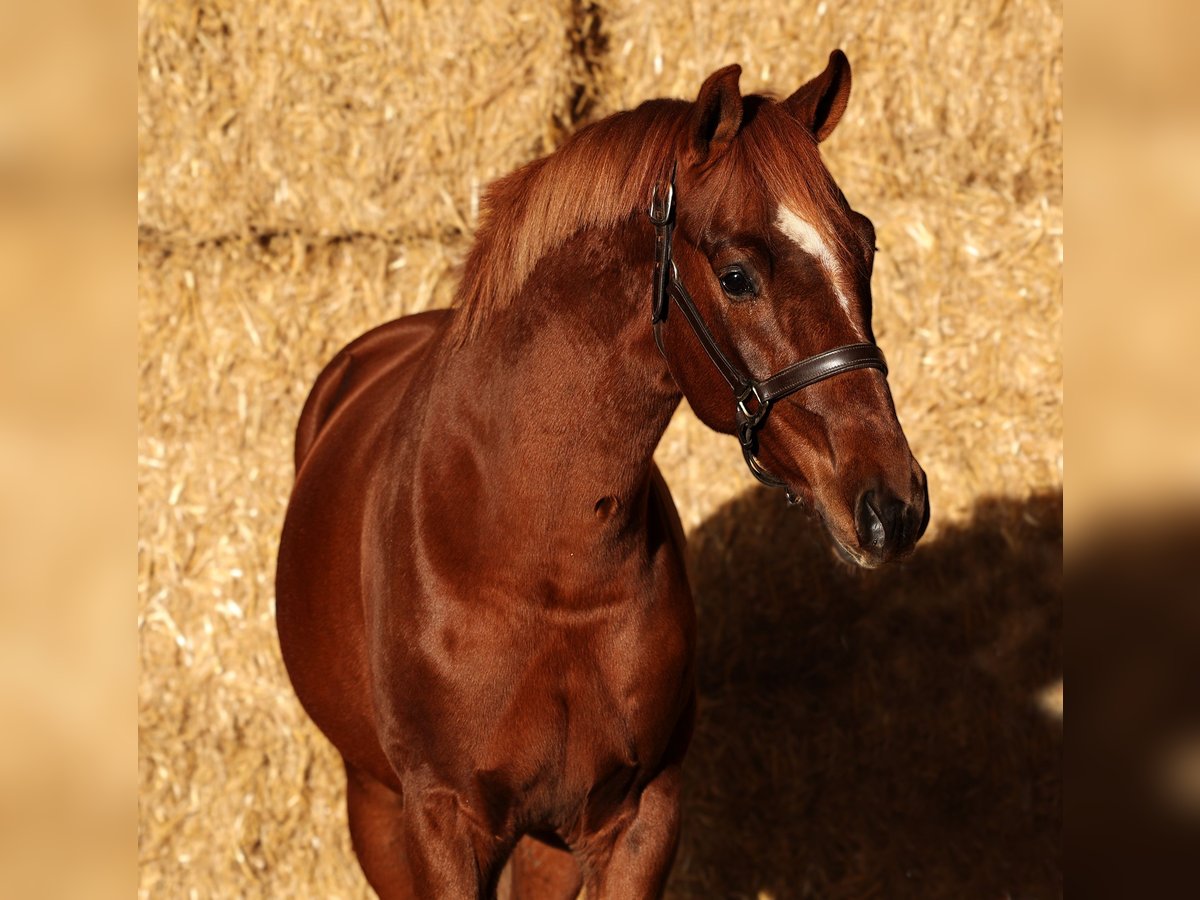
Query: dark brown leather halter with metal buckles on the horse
649 168 888 503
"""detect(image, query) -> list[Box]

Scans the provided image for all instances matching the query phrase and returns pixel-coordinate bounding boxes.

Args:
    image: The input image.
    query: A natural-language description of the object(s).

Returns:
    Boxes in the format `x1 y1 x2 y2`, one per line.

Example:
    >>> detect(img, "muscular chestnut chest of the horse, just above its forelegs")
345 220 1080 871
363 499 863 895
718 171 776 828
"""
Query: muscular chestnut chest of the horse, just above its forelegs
379 600 692 817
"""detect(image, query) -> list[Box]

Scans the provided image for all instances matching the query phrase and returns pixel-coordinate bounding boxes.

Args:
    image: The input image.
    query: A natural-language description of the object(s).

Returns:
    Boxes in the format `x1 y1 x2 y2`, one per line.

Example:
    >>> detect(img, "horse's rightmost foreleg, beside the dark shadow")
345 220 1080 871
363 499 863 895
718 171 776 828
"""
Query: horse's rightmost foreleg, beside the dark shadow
584 764 680 900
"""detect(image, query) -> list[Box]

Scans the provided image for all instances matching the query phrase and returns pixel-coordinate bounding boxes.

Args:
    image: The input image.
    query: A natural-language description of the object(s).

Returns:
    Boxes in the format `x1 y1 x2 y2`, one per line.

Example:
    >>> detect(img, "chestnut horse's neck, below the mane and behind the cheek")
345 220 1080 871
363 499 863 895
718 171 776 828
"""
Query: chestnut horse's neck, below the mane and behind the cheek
432 215 680 530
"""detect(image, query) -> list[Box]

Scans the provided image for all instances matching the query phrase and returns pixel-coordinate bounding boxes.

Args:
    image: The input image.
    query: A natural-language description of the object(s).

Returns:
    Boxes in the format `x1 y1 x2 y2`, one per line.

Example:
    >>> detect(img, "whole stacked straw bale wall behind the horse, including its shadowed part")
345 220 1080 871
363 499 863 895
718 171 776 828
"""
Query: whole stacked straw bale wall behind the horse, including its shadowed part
138 0 1063 898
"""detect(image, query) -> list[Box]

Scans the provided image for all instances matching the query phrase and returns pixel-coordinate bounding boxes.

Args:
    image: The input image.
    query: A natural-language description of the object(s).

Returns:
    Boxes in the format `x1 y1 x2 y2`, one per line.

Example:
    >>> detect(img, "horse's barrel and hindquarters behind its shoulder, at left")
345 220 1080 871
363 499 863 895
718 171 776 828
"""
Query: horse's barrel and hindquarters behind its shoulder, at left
276 311 448 782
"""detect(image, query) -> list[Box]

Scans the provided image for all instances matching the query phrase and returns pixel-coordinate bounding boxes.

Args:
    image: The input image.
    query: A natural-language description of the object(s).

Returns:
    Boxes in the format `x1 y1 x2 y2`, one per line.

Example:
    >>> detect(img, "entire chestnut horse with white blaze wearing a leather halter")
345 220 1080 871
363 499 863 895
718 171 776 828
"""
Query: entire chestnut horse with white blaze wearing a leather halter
277 52 928 899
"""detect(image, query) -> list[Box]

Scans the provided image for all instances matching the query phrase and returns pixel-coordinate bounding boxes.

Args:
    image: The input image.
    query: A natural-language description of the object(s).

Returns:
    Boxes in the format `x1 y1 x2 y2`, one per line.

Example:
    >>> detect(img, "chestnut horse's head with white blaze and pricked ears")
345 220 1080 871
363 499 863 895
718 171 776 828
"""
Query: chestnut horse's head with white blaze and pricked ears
652 50 929 568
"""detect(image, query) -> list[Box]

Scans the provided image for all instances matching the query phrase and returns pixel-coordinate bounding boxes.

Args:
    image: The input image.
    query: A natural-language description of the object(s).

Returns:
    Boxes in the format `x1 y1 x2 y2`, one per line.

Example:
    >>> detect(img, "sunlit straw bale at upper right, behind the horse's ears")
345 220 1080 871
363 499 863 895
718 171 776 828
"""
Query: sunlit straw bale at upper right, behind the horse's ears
596 0 1062 203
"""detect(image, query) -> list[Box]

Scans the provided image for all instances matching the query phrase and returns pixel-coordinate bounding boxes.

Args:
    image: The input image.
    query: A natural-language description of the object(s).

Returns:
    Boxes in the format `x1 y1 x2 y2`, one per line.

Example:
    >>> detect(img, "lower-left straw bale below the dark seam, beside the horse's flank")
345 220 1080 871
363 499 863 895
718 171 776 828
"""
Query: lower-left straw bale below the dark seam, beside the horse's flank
138 236 456 896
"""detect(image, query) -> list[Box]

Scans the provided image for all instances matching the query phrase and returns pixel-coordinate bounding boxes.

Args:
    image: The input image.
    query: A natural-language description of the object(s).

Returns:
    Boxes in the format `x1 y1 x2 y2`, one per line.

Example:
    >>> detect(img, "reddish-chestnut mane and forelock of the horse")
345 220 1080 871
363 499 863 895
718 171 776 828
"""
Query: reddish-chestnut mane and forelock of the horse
451 95 845 341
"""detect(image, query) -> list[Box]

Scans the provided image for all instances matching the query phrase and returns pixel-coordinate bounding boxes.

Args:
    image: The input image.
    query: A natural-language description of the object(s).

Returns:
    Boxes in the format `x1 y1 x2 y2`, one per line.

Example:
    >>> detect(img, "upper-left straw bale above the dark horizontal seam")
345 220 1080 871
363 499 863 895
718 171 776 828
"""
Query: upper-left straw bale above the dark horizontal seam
138 0 574 238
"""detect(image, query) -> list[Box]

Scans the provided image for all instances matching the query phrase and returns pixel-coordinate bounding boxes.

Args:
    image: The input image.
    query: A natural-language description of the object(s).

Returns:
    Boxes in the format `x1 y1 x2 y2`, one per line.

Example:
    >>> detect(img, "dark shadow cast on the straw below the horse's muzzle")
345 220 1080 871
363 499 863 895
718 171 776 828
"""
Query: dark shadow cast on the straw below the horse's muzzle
671 490 1063 899
